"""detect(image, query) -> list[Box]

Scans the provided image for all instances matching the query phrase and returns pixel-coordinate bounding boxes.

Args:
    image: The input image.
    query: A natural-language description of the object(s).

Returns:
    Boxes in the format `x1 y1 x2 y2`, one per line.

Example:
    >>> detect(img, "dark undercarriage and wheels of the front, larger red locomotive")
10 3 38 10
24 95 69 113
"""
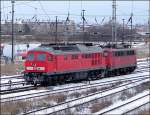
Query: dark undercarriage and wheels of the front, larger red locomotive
24 69 104 86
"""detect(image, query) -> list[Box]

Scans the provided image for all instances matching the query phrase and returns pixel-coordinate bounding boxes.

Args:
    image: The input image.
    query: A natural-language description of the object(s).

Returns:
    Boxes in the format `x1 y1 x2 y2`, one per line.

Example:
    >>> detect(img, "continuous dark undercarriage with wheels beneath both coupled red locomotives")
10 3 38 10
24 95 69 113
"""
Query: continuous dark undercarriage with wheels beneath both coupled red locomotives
24 66 136 86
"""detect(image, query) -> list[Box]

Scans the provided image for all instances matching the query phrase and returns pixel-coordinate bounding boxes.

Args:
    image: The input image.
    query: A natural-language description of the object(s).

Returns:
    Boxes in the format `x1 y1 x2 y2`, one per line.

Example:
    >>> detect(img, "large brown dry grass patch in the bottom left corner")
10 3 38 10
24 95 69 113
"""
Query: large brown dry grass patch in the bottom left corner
1 94 67 114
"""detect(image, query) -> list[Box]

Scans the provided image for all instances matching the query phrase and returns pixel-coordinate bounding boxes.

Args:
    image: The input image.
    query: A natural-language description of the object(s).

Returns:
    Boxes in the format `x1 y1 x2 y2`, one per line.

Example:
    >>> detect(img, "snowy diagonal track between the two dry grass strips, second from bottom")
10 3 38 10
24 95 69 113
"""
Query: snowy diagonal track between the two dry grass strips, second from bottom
23 77 149 114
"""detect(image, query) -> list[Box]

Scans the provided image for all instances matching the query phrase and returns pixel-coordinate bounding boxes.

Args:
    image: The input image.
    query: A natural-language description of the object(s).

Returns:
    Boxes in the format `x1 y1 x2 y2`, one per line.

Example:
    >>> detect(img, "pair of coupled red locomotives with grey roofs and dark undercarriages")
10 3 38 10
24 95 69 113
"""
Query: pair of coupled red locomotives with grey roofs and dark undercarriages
24 44 136 85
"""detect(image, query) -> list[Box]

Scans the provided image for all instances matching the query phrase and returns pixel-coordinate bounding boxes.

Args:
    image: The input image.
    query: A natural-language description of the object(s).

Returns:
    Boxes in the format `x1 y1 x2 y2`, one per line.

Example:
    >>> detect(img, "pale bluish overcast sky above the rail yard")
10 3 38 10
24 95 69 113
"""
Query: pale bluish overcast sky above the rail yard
1 1 149 24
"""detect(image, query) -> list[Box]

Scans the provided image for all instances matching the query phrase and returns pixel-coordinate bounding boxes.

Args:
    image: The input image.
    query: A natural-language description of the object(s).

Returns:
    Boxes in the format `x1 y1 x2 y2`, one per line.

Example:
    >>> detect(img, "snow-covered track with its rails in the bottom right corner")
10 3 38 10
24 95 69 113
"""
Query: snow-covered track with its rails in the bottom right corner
96 91 150 115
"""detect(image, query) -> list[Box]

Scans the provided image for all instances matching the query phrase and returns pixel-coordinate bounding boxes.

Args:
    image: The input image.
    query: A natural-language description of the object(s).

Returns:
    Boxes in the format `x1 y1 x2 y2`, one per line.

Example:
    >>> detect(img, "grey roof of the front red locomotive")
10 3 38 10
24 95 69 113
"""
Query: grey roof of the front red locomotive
30 44 102 54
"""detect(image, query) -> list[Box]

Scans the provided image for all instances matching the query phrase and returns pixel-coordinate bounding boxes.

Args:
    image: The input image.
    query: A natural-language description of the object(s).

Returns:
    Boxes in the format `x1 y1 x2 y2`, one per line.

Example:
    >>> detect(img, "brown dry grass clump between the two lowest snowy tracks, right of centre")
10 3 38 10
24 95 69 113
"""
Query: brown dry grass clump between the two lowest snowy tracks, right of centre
90 100 112 113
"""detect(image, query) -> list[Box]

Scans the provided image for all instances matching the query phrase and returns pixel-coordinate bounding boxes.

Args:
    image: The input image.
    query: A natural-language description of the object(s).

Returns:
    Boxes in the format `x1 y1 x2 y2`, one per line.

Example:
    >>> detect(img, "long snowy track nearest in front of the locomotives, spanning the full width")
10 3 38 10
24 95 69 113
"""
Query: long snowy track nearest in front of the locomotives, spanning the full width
1 72 149 103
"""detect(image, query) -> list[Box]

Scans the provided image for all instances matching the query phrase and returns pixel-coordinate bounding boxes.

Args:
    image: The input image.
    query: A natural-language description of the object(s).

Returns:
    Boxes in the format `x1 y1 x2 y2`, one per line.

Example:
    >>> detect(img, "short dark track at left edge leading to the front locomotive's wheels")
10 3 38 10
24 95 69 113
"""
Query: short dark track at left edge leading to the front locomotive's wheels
0 86 36 95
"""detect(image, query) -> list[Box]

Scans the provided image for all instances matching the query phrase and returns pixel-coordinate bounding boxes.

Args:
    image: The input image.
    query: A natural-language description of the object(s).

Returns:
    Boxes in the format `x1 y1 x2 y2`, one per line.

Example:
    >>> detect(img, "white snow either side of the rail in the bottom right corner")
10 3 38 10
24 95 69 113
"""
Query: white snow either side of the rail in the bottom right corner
95 90 150 115
